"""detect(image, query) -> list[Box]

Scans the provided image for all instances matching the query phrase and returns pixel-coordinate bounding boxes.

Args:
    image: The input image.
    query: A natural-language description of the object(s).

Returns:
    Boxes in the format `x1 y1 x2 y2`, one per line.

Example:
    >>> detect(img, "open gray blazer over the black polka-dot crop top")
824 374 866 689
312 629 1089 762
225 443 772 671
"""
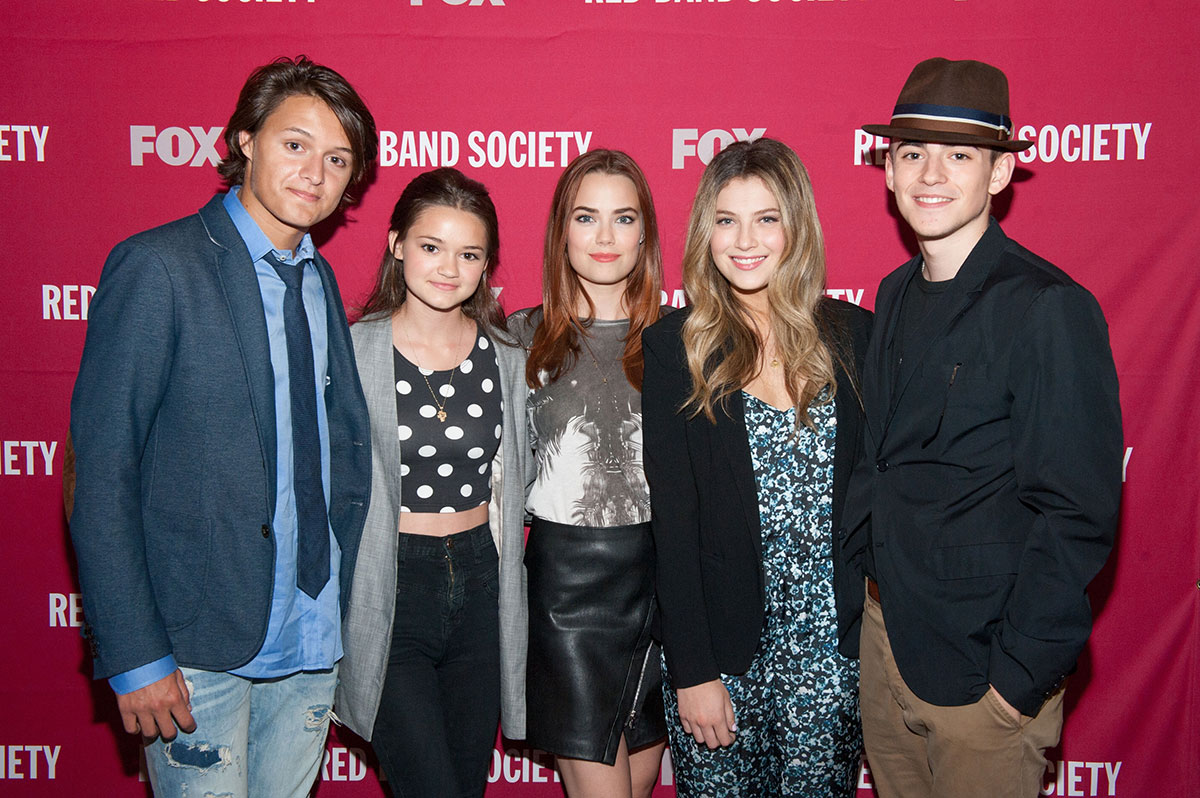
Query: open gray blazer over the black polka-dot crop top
334 318 534 740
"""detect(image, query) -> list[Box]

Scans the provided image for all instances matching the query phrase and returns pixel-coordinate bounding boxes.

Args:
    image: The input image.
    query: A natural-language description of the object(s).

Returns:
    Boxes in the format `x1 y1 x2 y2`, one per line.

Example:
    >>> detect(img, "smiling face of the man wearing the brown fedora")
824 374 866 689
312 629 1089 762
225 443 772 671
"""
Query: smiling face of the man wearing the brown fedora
886 142 1014 263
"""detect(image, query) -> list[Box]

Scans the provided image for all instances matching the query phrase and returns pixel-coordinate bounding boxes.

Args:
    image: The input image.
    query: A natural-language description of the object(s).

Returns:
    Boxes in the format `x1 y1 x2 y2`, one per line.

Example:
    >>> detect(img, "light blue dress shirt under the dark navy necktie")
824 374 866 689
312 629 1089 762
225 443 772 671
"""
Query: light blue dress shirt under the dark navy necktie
108 186 342 694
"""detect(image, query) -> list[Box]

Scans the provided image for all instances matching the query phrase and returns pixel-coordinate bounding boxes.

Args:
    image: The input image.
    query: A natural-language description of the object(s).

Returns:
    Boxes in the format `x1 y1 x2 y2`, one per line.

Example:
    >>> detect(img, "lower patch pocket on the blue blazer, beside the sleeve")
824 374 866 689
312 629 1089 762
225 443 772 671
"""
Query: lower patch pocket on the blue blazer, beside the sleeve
142 508 212 631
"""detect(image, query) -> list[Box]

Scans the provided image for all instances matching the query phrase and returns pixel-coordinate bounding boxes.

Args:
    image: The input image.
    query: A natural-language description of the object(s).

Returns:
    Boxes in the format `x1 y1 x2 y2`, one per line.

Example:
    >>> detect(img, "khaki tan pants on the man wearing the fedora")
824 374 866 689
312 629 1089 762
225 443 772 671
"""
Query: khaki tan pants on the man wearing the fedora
859 585 1062 798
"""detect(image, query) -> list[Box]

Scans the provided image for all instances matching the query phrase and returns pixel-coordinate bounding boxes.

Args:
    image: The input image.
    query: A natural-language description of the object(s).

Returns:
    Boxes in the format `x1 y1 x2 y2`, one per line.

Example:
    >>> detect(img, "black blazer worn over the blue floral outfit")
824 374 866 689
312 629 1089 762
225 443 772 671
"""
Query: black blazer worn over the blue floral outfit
642 300 871 688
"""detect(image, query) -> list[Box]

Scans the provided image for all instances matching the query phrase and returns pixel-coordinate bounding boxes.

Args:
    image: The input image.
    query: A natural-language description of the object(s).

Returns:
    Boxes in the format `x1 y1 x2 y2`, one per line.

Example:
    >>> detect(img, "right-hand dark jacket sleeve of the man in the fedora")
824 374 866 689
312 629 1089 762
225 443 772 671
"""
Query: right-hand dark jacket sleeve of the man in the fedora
989 284 1123 715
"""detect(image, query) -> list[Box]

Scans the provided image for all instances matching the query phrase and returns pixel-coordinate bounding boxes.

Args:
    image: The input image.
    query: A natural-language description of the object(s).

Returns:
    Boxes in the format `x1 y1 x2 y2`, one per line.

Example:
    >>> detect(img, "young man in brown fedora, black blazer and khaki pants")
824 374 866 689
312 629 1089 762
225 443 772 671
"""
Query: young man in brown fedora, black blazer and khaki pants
842 59 1123 798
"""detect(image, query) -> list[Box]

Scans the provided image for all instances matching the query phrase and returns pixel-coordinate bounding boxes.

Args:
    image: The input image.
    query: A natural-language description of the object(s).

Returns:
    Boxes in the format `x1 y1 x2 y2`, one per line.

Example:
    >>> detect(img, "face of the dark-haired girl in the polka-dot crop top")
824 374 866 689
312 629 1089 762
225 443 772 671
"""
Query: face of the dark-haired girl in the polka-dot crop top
388 205 487 312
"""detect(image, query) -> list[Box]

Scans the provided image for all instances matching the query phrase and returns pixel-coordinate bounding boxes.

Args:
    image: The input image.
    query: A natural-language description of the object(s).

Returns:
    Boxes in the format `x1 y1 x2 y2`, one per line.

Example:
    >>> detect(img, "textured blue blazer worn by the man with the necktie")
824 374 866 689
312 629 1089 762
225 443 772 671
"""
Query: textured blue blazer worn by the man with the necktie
71 196 371 678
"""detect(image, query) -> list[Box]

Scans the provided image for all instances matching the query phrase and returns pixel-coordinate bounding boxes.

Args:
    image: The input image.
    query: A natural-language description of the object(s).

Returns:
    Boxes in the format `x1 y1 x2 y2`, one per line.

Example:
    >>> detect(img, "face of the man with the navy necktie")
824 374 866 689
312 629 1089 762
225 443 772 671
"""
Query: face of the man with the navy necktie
238 95 354 250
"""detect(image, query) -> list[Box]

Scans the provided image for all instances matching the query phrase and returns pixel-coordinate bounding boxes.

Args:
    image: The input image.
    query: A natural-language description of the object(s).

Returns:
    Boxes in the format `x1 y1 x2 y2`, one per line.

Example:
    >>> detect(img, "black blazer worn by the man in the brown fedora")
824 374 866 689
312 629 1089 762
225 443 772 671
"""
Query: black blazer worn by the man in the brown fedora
847 222 1123 715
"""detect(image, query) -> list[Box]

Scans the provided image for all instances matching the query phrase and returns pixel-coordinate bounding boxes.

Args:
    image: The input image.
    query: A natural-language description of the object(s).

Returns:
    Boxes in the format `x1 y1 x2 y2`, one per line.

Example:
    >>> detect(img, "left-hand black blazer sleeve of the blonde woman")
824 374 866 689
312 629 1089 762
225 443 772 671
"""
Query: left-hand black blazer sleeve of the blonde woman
642 330 721 689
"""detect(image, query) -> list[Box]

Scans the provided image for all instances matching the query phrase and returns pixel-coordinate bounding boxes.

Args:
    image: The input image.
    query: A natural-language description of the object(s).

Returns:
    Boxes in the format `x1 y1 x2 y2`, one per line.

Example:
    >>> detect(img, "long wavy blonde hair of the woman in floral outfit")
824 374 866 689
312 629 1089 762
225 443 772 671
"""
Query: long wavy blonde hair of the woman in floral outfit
683 138 848 427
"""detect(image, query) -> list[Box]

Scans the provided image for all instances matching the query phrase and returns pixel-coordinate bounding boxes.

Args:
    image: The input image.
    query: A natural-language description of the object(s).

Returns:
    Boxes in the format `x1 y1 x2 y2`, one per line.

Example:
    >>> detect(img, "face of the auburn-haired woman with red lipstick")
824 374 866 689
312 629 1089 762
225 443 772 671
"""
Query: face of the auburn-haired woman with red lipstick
566 172 642 294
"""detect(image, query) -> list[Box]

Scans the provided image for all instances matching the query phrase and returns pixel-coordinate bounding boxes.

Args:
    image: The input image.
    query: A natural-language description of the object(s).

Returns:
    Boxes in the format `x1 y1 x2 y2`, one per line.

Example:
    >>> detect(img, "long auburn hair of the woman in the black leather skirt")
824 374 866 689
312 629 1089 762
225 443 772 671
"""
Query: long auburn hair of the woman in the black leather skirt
526 150 662 390
